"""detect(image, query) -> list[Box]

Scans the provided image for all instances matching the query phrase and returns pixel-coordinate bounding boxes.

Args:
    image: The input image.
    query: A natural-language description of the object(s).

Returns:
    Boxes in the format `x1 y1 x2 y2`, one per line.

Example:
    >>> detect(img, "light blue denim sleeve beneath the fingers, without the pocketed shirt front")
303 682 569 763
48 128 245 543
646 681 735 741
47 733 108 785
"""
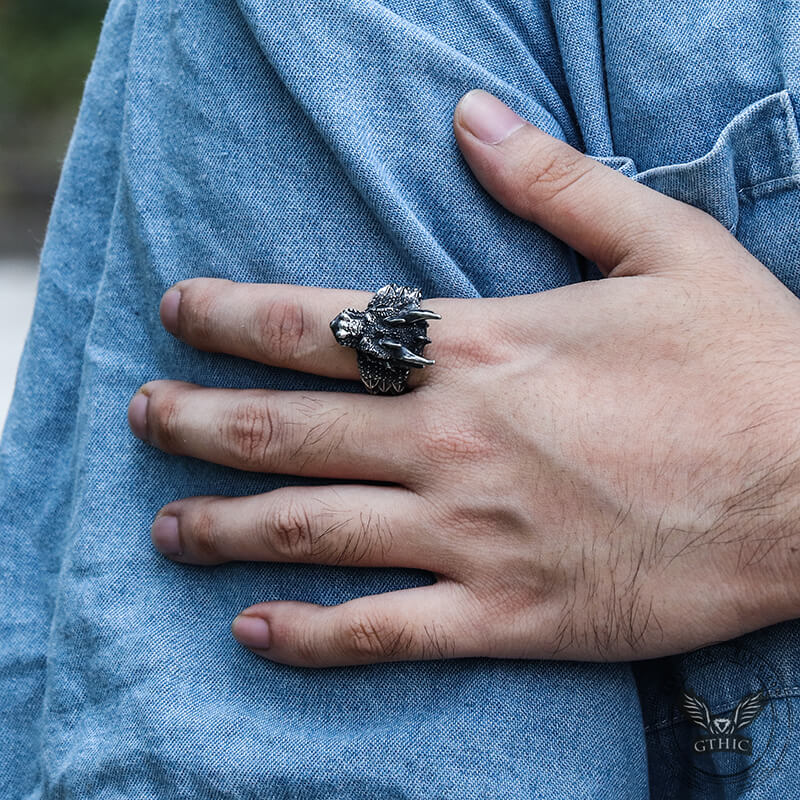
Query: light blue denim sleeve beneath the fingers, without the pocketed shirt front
0 0 647 800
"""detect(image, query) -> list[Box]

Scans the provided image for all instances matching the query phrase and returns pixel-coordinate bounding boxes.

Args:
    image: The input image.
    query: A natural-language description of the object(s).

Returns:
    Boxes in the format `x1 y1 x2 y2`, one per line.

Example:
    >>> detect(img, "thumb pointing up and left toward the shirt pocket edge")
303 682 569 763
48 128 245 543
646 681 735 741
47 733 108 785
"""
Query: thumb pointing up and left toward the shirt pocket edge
453 89 724 275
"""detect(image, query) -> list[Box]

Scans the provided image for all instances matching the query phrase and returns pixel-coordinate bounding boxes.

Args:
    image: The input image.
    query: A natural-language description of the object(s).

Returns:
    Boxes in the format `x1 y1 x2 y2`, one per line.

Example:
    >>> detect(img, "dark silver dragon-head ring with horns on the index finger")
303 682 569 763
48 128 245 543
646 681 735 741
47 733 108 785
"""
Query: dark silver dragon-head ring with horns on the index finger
331 283 441 394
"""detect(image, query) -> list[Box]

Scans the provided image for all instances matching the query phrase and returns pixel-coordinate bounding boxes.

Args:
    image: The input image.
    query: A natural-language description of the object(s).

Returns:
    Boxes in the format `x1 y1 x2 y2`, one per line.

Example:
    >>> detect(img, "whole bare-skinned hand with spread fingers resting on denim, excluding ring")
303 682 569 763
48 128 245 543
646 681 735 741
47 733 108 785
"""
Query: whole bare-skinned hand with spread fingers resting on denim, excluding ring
129 92 800 667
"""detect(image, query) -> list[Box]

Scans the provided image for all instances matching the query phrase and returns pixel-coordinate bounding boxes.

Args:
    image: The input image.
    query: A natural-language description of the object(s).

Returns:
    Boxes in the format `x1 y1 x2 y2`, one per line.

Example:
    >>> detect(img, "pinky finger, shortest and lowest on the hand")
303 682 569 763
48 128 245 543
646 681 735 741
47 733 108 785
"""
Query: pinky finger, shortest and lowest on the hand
232 579 489 667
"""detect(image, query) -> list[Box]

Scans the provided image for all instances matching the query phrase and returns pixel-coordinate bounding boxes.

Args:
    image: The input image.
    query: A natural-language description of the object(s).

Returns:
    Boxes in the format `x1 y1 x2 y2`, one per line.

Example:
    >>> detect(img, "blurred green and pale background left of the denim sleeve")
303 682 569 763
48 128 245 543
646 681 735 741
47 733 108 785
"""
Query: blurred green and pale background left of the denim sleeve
0 0 108 428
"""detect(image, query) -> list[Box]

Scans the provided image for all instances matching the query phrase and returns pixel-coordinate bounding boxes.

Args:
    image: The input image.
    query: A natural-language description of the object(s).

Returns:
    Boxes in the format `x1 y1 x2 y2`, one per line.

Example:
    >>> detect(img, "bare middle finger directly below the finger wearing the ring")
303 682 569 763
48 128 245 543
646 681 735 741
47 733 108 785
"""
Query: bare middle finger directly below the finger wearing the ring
128 381 413 483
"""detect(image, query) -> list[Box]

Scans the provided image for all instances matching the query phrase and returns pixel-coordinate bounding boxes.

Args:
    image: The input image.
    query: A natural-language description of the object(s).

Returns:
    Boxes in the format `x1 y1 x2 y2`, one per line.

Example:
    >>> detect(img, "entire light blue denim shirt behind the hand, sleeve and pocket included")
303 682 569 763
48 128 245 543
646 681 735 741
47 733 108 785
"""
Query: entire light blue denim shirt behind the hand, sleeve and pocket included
0 0 800 800
